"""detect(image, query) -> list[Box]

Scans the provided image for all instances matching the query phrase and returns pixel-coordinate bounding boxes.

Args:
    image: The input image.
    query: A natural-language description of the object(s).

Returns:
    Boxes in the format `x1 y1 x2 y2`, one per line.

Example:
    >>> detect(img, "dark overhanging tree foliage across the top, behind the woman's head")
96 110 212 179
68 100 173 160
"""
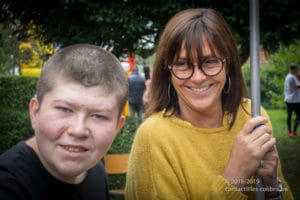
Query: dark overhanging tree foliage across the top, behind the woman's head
1 0 300 60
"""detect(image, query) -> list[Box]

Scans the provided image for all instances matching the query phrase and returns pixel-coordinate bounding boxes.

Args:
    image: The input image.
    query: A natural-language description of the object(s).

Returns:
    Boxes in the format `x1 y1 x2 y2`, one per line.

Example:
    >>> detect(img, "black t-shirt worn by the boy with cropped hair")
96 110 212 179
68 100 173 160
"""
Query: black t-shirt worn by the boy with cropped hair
0 141 109 200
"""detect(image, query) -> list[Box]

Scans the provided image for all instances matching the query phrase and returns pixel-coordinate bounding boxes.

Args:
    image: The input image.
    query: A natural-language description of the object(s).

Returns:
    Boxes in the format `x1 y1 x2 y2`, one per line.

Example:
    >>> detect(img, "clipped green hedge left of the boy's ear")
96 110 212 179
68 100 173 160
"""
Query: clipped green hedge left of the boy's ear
0 76 37 153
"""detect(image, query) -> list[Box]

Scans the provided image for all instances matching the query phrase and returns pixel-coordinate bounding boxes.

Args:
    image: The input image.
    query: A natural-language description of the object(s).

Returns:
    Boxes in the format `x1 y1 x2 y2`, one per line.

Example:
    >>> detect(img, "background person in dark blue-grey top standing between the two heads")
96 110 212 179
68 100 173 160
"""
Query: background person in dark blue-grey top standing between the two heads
128 66 145 123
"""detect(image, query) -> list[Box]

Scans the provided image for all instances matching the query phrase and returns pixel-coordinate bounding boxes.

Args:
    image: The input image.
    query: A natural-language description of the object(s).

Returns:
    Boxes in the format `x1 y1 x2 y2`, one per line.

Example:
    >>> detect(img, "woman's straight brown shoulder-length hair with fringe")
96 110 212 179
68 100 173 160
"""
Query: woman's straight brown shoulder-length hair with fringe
147 8 245 127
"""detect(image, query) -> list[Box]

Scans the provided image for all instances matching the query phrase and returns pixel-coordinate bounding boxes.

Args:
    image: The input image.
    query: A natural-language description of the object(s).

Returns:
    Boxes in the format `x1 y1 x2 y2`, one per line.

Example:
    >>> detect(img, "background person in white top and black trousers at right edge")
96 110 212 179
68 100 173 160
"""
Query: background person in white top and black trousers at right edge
284 64 300 137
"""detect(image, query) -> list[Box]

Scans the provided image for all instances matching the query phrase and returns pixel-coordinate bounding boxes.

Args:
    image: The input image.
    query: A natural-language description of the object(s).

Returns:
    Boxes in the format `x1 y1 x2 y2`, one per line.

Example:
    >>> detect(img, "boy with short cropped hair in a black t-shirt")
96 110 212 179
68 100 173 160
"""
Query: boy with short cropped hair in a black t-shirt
0 44 128 200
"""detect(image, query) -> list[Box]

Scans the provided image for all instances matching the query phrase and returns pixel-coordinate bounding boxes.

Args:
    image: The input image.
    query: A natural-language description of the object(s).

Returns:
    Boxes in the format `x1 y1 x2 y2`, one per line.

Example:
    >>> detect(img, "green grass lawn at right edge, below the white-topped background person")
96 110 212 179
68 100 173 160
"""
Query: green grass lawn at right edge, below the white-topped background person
267 110 300 199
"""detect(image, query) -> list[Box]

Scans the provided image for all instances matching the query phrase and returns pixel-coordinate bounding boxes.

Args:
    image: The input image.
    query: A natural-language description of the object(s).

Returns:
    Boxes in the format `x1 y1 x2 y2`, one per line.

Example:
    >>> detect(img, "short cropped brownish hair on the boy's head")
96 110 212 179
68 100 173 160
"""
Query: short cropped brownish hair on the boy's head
36 44 128 113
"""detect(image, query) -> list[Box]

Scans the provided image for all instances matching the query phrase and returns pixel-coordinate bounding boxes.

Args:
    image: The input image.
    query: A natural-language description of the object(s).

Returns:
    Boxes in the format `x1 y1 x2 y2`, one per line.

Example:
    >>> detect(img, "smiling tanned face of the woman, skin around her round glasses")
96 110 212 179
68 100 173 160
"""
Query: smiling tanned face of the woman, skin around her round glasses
171 45 226 113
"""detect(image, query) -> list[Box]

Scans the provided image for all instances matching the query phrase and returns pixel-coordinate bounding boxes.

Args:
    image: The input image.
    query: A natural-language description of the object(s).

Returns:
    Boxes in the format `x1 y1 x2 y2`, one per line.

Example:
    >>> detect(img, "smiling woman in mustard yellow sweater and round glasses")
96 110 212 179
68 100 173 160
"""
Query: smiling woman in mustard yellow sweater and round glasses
126 9 292 200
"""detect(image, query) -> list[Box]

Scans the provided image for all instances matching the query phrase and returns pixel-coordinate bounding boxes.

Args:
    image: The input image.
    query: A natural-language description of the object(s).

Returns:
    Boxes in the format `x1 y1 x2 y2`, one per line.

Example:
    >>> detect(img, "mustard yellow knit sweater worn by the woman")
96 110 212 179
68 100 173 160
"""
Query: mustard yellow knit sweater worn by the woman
126 101 293 200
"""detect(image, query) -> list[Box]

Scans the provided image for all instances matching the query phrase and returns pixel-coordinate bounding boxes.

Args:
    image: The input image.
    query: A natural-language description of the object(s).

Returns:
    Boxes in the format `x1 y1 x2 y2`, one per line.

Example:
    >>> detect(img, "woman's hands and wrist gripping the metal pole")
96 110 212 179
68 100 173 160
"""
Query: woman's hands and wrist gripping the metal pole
223 116 277 187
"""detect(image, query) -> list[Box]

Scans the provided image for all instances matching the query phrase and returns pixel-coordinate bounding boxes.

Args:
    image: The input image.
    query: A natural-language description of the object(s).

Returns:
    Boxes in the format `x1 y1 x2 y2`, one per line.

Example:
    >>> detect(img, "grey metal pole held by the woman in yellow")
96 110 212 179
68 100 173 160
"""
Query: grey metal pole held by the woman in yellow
249 0 265 200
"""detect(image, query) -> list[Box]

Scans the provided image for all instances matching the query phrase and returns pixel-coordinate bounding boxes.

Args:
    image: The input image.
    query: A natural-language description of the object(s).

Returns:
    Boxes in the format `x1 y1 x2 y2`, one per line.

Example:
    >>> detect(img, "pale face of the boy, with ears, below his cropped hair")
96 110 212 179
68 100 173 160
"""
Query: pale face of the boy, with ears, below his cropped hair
30 81 125 183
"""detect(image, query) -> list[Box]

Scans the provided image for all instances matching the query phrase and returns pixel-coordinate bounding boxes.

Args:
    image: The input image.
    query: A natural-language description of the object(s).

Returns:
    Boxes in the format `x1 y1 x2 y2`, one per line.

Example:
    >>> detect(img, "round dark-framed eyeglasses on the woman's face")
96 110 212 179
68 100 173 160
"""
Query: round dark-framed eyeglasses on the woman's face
168 57 226 80
